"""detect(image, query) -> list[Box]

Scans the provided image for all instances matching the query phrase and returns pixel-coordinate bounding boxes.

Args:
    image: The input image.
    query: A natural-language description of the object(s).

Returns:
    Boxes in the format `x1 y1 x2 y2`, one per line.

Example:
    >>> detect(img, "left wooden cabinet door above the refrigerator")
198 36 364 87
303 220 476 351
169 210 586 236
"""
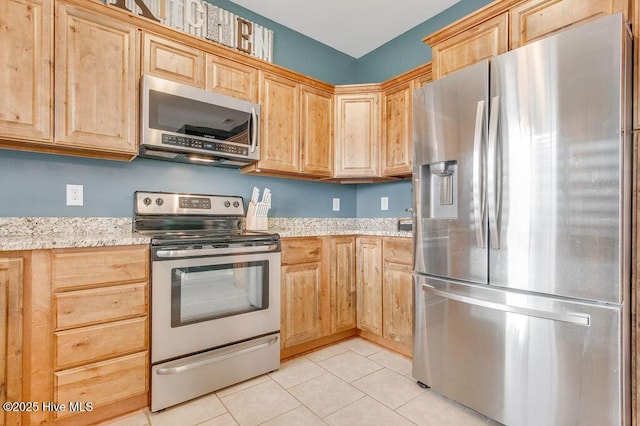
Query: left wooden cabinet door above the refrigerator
431 13 509 79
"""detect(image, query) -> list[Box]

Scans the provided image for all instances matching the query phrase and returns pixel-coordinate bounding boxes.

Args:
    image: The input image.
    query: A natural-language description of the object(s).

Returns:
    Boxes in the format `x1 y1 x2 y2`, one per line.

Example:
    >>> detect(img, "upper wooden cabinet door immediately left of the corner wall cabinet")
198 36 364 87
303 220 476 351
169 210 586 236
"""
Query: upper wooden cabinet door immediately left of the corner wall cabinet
300 85 333 177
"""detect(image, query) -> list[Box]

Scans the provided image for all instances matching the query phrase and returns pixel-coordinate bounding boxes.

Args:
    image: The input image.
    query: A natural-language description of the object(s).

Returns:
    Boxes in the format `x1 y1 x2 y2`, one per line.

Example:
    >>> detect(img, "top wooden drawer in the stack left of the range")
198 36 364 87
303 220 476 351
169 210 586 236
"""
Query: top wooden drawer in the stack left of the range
52 246 149 290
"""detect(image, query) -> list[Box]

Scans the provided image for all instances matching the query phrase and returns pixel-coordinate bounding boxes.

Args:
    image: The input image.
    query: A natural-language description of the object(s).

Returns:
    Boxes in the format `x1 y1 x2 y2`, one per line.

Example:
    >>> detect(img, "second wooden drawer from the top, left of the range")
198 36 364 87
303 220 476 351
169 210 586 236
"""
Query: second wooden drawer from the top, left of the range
54 283 147 329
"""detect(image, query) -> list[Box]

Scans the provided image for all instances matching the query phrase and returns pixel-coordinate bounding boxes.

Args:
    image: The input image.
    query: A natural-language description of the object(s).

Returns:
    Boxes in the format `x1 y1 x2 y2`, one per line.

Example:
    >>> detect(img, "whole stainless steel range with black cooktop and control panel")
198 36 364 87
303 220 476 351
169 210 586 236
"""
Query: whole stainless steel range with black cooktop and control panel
133 191 280 411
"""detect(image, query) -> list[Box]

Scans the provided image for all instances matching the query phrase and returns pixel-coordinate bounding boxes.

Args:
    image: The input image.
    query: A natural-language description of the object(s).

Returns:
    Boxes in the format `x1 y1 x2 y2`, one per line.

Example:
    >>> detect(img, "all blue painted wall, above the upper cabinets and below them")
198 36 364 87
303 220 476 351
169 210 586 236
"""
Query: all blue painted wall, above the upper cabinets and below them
0 0 489 217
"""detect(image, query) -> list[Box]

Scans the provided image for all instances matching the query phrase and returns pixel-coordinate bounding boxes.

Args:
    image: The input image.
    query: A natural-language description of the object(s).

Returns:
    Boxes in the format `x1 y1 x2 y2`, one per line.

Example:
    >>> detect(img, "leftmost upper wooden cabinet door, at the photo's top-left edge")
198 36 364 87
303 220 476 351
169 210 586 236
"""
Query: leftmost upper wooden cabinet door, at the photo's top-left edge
0 0 53 142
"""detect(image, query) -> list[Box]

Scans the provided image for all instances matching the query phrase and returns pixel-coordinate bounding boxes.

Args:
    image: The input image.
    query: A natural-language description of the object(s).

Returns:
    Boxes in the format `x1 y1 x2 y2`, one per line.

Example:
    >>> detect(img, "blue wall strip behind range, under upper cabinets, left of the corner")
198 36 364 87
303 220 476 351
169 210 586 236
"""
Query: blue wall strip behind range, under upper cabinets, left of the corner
0 150 357 217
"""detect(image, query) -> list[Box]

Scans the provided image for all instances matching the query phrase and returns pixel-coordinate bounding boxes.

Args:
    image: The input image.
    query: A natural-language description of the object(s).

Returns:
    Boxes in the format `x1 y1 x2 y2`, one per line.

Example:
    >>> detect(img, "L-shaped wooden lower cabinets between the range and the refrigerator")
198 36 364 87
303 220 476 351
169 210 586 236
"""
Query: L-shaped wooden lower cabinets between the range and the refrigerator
280 236 413 358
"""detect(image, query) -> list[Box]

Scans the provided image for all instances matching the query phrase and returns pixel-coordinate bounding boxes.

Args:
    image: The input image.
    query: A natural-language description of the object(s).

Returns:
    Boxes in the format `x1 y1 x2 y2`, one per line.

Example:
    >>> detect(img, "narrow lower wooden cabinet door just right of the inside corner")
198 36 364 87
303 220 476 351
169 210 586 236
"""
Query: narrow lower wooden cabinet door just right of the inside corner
356 238 382 336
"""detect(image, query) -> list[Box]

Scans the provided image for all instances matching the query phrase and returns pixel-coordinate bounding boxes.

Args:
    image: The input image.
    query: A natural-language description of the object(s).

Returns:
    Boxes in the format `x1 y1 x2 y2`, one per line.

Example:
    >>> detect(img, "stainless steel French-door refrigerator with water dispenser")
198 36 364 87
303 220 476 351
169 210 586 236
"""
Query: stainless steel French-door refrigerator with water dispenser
413 14 631 426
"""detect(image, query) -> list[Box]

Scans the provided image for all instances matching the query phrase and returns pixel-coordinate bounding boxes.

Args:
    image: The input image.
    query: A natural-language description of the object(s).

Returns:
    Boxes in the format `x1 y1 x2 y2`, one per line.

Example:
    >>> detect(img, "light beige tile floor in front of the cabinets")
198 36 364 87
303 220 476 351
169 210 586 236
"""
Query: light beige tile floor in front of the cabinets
104 338 496 426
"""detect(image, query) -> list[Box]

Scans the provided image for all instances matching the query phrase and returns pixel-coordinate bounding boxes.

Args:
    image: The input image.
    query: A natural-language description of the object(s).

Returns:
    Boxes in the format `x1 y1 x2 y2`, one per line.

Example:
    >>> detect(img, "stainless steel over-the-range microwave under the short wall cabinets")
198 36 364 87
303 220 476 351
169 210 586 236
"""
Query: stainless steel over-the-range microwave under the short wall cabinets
139 75 260 168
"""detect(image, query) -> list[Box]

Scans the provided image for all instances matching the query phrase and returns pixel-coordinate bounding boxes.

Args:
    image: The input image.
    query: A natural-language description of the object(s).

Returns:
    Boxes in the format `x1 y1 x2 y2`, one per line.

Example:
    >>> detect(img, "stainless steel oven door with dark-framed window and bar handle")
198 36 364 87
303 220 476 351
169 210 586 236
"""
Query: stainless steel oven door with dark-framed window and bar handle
151 249 280 363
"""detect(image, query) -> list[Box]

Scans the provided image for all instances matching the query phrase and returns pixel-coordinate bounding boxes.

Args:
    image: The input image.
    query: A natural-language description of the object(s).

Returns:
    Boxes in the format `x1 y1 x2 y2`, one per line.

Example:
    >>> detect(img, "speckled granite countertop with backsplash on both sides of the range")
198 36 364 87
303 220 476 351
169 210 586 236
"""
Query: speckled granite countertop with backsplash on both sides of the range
0 217 412 251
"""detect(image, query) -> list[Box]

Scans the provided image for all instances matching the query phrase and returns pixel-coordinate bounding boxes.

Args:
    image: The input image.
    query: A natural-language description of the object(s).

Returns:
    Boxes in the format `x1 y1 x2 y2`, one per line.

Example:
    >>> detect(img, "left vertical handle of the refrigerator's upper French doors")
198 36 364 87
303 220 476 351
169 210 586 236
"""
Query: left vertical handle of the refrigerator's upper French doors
473 101 485 248
